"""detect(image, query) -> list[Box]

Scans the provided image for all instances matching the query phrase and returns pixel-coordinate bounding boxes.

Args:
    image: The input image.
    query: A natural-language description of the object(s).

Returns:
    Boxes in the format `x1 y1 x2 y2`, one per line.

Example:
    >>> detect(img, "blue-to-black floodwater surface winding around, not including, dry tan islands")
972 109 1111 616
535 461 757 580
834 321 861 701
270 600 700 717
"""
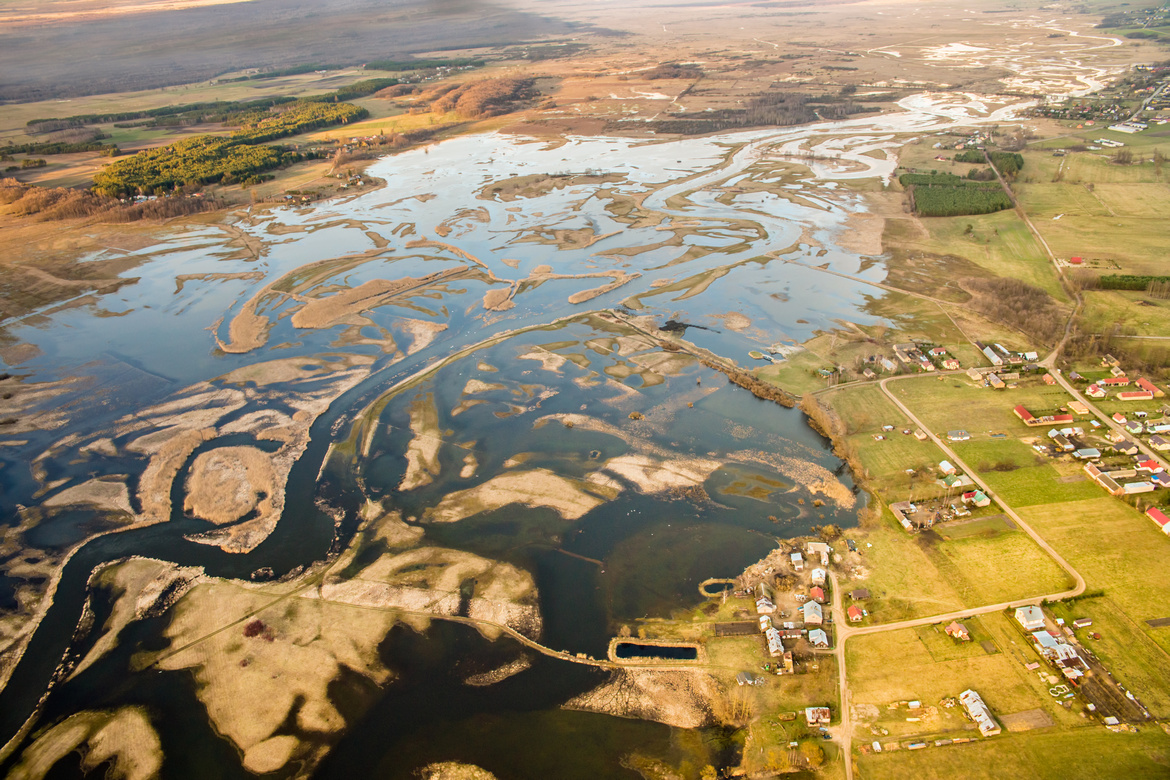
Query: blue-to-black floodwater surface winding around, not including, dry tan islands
0 94 1013 778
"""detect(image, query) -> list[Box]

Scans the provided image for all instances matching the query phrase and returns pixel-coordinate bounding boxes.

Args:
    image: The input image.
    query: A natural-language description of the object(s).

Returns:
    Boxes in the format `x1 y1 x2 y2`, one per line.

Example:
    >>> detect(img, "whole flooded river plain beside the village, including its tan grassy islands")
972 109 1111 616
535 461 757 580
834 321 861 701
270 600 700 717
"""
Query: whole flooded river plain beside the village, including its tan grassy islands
0 94 1018 778
